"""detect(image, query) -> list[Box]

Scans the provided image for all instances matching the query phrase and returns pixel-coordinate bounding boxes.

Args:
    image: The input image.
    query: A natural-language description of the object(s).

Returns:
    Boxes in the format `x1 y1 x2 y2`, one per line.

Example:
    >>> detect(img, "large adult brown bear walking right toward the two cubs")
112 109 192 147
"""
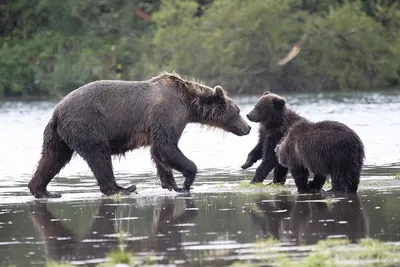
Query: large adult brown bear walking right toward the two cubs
28 73 250 198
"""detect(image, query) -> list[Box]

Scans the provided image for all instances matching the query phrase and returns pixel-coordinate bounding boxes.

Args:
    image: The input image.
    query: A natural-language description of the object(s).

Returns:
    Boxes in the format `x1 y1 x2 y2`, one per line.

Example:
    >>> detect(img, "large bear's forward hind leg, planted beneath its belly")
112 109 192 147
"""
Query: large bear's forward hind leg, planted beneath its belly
76 144 136 196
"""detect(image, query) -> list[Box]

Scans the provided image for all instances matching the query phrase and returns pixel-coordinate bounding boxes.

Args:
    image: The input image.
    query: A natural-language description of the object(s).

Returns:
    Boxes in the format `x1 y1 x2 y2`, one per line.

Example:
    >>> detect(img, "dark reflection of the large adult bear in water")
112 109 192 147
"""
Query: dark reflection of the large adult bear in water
30 198 198 266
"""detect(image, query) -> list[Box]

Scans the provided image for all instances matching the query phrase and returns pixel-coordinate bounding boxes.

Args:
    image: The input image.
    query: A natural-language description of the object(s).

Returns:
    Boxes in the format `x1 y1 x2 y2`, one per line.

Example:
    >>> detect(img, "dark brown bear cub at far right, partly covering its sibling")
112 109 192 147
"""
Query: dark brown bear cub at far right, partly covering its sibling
275 120 365 193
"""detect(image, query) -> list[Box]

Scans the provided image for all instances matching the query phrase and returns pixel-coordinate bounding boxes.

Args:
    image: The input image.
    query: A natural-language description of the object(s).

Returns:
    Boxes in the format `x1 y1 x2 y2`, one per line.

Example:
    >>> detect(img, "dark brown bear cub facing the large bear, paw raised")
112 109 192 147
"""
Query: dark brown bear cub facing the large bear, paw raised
242 91 316 184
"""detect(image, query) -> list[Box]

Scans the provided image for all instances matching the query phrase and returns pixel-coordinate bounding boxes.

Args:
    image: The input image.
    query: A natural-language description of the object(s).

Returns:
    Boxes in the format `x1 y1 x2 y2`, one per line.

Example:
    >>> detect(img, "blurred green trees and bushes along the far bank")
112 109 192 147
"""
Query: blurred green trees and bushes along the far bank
0 0 400 97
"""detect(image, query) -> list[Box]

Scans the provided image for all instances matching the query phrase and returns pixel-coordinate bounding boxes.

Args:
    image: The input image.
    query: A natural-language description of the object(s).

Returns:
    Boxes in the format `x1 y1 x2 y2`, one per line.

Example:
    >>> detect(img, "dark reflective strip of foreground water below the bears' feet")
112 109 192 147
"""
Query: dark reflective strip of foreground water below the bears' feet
0 190 400 266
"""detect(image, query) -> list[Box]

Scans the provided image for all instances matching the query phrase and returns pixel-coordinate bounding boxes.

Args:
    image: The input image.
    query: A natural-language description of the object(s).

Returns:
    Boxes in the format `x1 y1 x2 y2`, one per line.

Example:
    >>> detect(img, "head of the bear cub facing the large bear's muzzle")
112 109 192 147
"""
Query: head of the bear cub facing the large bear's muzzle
247 91 286 125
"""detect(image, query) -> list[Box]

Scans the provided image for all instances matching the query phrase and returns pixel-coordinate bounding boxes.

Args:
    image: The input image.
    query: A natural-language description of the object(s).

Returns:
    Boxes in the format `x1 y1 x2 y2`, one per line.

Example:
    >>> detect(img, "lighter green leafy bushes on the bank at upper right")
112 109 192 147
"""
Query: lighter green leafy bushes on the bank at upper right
154 0 400 91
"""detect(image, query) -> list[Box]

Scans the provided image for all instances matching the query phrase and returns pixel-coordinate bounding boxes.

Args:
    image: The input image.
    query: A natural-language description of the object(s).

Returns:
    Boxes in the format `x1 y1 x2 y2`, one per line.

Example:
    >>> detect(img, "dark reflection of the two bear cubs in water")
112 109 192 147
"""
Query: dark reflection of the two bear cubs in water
248 193 367 245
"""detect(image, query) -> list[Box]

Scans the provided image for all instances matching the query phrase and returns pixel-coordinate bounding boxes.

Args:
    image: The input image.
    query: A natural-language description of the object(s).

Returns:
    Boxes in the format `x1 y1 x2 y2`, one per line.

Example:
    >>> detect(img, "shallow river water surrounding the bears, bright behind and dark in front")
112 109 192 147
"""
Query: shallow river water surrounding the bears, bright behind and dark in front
0 91 400 266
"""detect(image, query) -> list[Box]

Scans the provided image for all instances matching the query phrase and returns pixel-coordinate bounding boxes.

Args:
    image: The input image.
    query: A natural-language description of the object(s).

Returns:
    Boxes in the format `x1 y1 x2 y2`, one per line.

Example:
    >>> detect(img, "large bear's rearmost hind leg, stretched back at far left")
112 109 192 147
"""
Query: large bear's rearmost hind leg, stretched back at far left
28 140 73 198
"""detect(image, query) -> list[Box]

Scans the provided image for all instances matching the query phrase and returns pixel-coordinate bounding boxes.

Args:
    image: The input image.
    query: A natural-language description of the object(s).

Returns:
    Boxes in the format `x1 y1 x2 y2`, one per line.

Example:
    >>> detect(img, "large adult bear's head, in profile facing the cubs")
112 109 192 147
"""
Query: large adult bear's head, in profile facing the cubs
192 85 251 136
